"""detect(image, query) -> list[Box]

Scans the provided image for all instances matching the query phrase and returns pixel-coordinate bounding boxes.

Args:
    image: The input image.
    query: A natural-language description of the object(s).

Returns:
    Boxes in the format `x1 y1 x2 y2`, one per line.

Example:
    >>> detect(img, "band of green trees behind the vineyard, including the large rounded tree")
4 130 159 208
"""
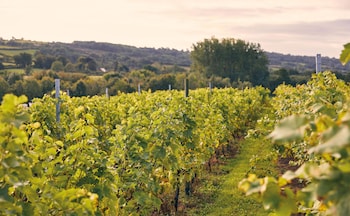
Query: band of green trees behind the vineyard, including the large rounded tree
0 37 350 99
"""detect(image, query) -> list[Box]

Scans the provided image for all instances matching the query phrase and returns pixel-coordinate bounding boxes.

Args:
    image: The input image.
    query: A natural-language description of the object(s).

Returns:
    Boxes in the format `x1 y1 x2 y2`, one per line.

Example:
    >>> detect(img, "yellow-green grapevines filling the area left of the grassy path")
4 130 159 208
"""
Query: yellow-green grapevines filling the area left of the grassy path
0 87 270 215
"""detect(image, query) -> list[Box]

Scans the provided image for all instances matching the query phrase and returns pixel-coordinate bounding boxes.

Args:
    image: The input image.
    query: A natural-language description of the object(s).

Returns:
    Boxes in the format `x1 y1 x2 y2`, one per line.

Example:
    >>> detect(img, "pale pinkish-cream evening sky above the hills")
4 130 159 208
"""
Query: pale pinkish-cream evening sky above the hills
0 0 350 58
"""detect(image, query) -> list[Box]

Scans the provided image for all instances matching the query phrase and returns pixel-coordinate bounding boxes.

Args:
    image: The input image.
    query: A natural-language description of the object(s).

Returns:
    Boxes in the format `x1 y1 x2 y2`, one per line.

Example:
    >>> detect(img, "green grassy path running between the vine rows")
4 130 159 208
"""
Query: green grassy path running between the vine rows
187 138 275 216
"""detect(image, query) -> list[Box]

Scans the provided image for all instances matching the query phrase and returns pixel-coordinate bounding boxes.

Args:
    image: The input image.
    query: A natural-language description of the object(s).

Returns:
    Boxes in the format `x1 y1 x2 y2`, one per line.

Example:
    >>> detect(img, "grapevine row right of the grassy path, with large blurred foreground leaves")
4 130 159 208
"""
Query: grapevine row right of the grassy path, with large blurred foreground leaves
240 72 350 216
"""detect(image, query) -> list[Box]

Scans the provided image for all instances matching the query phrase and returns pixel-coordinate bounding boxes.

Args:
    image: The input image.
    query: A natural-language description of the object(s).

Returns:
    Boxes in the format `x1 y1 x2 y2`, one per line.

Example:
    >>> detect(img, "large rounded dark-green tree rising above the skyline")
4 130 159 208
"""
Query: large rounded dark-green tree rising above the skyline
191 37 269 85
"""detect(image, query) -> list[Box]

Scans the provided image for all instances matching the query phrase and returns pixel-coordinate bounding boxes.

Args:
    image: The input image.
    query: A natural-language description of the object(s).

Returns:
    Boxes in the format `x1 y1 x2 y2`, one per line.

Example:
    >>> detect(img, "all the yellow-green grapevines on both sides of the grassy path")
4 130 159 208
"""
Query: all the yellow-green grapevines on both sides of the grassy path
0 72 350 215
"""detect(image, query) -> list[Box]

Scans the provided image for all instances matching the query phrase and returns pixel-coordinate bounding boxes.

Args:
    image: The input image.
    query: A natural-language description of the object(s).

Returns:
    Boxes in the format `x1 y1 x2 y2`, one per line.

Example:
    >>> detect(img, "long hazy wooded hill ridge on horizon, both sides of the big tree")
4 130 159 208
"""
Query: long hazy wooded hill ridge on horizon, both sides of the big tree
0 38 350 72
